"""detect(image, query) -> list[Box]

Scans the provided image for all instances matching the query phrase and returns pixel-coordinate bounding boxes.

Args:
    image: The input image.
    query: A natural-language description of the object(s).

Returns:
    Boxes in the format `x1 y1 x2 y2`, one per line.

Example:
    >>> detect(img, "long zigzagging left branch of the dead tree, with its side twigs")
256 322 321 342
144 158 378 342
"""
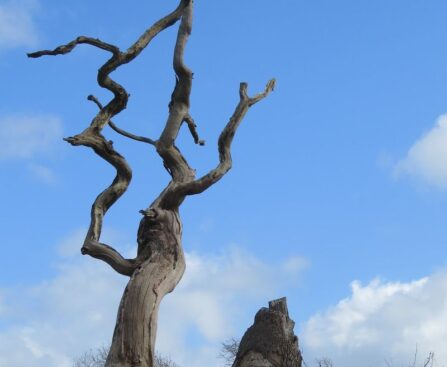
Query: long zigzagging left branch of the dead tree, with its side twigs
28 0 191 275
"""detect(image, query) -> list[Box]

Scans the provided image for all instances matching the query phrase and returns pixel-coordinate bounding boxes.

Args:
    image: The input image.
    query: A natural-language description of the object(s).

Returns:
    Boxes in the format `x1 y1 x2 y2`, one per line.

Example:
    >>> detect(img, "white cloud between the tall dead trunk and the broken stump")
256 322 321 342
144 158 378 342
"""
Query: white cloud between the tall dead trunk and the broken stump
158 247 304 367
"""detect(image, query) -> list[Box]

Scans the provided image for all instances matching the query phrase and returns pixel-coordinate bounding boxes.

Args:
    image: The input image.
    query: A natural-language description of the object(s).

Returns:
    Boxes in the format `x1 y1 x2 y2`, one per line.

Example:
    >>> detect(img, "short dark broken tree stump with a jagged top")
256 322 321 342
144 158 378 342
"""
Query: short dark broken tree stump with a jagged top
233 298 302 367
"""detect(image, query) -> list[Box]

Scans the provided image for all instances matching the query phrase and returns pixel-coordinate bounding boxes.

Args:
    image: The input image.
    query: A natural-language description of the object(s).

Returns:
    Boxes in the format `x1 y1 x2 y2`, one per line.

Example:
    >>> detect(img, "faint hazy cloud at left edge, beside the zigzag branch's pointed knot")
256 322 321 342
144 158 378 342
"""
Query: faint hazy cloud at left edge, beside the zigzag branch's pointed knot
0 115 62 160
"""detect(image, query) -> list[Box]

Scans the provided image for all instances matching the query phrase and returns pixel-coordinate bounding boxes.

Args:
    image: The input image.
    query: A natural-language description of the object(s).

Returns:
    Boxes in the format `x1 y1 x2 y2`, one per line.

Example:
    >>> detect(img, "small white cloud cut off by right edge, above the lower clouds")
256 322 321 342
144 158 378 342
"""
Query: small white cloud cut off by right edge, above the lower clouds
395 115 447 188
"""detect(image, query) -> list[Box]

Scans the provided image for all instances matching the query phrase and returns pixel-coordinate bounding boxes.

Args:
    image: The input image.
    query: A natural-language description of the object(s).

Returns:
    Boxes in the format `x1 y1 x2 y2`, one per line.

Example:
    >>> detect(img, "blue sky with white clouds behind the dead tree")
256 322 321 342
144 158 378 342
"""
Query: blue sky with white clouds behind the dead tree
0 0 447 367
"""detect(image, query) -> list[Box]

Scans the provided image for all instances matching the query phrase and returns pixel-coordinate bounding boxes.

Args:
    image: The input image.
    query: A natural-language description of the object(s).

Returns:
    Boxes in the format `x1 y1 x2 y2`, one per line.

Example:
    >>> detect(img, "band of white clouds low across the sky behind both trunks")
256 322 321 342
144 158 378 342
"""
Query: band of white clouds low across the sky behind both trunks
0 227 447 367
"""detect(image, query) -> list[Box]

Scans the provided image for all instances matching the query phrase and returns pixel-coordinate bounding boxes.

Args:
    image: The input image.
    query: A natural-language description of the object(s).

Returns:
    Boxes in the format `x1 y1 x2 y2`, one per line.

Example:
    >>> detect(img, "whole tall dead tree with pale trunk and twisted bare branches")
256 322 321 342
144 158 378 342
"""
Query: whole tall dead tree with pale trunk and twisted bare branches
28 0 275 367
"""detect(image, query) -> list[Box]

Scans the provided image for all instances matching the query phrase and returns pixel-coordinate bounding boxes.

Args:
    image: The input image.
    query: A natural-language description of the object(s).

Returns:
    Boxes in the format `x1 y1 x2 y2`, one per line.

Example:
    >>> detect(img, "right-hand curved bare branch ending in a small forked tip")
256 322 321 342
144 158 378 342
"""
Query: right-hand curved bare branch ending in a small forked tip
177 79 275 195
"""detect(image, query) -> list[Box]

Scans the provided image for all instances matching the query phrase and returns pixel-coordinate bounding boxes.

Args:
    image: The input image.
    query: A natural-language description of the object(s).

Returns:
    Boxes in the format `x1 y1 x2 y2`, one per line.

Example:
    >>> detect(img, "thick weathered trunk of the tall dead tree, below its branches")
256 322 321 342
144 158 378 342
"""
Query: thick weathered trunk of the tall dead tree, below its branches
106 208 185 367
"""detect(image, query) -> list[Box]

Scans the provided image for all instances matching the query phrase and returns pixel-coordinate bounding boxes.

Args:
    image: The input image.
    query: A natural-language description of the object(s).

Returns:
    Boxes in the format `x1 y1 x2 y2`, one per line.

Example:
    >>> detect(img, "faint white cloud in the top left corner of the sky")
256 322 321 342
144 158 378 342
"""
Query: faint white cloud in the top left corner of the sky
0 0 38 49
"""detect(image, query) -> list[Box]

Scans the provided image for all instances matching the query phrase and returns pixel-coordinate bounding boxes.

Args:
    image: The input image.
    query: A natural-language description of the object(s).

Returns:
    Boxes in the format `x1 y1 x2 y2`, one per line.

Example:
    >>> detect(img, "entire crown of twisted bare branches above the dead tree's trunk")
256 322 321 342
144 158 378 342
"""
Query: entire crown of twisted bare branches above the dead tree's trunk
28 0 275 275
